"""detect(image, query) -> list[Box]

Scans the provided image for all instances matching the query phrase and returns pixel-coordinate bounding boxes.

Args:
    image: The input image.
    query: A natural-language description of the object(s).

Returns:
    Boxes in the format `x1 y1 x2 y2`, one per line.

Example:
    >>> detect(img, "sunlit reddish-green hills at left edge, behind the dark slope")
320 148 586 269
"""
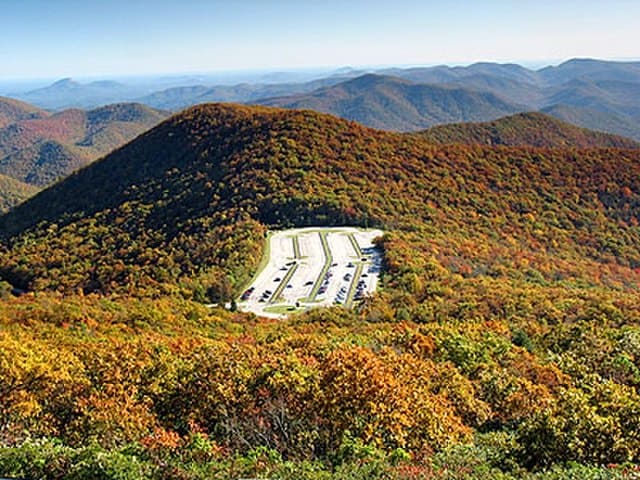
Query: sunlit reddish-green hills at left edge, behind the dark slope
0 104 167 186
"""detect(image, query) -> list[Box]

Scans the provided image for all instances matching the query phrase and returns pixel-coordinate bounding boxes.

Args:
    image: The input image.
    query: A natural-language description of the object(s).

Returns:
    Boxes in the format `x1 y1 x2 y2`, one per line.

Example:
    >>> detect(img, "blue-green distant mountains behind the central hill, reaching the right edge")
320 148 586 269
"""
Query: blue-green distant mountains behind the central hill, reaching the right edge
255 60 640 140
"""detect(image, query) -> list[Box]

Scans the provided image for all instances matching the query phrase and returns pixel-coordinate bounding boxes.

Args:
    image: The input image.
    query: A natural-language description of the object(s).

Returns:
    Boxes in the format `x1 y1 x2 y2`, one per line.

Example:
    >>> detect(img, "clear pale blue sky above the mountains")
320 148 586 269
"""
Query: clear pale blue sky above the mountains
0 0 640 80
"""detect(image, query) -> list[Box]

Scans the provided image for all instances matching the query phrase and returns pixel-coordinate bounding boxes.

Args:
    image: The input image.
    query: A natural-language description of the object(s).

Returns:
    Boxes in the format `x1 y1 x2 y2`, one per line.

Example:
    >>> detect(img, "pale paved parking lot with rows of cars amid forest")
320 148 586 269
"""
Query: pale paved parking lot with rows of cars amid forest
238 227 383 318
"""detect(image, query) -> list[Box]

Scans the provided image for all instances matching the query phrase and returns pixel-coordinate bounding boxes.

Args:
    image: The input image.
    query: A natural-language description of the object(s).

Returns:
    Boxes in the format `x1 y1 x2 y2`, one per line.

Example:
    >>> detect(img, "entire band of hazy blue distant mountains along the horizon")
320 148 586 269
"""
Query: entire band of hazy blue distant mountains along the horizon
8 59 640 140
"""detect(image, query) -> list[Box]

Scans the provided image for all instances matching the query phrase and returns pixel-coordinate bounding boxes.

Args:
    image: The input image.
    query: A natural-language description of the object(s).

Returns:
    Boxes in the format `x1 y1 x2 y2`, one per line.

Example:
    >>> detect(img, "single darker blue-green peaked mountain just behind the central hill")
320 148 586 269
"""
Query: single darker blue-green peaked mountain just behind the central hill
256 75 522 131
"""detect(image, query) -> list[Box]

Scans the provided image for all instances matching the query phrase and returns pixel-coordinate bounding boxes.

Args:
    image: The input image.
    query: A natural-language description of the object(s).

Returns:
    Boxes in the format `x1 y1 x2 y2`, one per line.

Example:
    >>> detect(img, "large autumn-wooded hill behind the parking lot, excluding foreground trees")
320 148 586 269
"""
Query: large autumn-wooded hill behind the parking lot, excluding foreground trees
0 105 640 299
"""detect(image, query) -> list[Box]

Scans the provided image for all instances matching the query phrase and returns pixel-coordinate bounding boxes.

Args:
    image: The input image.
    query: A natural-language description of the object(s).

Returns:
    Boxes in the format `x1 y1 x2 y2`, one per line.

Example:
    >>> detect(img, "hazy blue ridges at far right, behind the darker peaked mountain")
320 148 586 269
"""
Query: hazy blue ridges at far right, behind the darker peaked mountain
385 59 640 141
